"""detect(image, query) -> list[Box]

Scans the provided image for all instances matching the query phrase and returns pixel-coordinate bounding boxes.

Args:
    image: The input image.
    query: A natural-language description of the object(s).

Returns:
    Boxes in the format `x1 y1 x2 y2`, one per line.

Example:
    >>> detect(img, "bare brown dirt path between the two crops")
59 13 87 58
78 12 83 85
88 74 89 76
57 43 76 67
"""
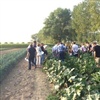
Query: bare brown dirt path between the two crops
0 59 51 100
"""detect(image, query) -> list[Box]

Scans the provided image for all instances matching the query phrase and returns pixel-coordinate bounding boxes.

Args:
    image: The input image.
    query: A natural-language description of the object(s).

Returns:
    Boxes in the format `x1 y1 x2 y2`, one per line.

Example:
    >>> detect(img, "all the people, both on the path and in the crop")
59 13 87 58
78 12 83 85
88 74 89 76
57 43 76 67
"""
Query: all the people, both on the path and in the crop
26 41 100 70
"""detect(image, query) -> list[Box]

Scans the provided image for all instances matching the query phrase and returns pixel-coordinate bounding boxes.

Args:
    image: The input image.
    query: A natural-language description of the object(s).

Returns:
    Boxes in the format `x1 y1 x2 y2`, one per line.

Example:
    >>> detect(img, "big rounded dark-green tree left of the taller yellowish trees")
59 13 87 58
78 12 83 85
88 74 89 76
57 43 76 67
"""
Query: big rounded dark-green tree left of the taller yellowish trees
43 8 71 41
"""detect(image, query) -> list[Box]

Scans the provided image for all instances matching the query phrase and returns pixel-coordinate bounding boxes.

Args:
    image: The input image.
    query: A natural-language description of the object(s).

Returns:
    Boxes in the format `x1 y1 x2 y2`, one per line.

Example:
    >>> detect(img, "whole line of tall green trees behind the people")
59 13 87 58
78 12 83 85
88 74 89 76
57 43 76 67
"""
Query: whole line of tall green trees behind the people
31 0 100 43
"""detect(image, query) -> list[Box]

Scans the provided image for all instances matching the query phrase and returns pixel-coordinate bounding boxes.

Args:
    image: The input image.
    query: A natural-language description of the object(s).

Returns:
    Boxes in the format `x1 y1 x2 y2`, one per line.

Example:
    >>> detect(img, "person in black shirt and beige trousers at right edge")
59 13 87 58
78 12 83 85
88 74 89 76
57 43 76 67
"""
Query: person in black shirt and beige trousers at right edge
93 41 100 67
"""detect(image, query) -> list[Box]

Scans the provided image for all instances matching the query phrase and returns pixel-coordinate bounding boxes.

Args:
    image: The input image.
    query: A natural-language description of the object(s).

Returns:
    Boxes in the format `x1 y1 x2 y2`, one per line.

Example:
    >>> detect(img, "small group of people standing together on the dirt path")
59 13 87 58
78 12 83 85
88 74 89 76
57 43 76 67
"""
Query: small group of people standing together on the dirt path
25 41 48 70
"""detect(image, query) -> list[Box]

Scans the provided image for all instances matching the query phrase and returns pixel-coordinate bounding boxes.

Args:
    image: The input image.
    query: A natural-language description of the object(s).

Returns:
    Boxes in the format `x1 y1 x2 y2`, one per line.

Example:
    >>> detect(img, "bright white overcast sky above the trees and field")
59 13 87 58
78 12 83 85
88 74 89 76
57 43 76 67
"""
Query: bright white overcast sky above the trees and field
0 0 83 43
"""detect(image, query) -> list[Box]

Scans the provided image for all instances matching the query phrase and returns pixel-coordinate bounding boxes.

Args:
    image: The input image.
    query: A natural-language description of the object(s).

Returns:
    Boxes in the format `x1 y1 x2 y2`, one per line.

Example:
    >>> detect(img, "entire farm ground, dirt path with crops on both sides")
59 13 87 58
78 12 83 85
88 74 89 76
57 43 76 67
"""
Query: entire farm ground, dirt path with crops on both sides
0 46 100 100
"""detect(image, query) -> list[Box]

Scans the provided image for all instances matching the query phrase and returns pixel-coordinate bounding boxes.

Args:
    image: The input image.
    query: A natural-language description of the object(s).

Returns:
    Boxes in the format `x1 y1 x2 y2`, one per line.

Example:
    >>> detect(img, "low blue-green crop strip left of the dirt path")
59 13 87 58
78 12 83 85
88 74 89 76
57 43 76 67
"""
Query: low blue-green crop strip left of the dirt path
0 48 26 82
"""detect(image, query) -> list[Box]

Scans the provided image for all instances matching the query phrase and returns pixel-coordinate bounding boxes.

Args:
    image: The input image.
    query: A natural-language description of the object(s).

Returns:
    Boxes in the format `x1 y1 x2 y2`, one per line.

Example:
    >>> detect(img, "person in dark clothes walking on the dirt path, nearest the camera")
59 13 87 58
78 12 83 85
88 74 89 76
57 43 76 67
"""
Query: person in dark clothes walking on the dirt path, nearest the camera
27 44 36 70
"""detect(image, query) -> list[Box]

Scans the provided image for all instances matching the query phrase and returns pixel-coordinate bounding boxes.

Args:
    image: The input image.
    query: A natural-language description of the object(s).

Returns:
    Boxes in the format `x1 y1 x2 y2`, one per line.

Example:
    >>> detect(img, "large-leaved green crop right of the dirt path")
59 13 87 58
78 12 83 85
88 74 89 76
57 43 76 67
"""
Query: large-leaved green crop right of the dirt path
43 54 100 100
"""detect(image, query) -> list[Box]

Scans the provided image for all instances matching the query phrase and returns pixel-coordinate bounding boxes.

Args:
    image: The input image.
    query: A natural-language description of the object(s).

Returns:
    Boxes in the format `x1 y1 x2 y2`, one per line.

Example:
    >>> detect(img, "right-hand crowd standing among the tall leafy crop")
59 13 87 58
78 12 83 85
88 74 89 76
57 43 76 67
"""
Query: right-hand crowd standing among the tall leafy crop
52 41 100 67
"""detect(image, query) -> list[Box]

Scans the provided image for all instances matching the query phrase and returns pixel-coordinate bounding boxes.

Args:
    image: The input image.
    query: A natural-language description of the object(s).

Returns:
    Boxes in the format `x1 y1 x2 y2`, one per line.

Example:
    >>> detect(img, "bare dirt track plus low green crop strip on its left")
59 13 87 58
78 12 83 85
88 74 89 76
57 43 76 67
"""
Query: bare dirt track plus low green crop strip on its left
0 45 51 100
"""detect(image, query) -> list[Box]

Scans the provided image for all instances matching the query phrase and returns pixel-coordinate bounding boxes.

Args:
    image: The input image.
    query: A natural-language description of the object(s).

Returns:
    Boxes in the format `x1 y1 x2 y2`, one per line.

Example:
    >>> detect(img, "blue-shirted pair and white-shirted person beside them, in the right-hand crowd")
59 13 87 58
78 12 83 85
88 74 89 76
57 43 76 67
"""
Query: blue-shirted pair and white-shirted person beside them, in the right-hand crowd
52 42 79 61
